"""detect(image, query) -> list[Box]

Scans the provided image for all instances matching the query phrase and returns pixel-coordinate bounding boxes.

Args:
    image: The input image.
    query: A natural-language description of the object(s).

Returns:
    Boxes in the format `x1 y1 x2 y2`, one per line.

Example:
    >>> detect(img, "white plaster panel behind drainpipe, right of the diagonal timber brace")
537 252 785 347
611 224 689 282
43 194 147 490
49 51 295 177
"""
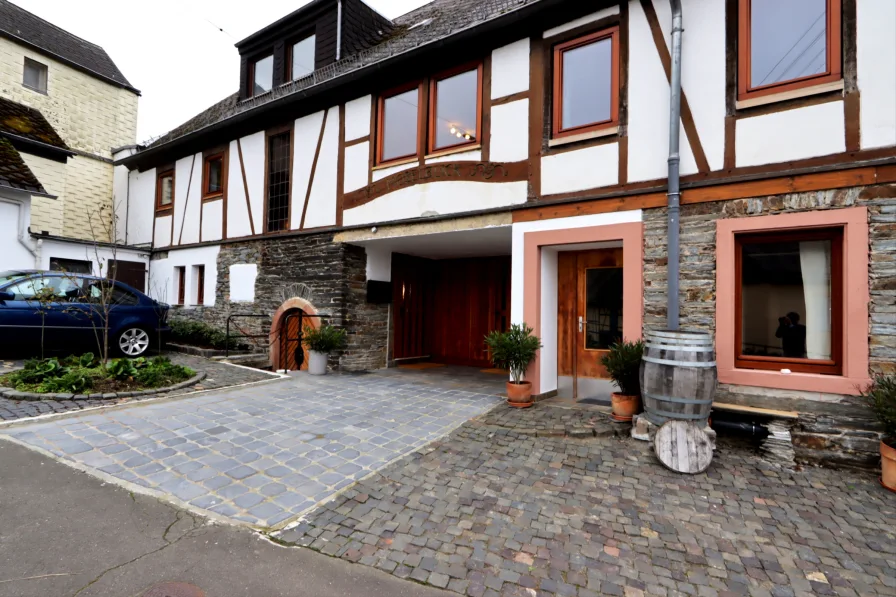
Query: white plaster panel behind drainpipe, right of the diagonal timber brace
653 0 726 170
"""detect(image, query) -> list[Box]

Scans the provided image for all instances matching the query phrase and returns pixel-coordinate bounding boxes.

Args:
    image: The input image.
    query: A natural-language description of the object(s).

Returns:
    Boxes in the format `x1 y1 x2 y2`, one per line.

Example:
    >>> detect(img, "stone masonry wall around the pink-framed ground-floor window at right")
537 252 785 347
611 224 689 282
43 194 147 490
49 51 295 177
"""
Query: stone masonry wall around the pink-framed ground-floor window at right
644 185 896 466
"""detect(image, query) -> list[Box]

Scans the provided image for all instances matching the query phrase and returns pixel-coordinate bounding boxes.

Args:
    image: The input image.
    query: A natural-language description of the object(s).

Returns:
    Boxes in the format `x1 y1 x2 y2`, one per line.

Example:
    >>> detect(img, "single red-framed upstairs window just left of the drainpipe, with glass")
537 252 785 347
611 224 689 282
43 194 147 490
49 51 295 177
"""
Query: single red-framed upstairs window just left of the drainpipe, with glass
552 27 619 138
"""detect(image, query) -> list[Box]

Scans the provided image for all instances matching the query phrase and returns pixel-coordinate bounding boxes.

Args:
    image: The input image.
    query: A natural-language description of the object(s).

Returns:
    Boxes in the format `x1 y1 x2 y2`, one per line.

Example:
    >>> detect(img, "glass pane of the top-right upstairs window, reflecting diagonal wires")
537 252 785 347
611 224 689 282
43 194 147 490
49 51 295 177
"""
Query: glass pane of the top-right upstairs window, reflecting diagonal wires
750 0 828 88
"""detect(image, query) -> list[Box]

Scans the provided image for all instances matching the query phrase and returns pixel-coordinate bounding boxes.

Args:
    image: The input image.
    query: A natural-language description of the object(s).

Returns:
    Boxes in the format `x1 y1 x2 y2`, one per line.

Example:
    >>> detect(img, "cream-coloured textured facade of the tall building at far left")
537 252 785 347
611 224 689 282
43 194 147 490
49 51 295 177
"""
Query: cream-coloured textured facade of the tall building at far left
0 38 137 241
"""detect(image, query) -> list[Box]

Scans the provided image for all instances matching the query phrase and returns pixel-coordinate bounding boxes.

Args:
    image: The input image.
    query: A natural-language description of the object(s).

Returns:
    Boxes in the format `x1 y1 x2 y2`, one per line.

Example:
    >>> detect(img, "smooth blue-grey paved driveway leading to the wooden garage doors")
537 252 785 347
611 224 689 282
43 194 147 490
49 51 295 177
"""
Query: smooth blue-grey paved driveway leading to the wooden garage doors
6 374 499 527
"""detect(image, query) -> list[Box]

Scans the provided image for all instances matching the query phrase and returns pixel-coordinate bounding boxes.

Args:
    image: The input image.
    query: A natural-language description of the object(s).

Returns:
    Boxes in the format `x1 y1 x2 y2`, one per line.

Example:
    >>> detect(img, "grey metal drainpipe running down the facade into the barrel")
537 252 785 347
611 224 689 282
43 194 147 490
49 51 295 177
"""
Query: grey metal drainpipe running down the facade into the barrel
666 0 683 330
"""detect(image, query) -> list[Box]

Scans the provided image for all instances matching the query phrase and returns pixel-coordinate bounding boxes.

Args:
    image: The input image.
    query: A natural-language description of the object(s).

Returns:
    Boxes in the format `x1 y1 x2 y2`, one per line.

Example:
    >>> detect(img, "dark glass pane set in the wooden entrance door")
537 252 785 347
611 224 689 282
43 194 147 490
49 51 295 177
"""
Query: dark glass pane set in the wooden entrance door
585 267 622 350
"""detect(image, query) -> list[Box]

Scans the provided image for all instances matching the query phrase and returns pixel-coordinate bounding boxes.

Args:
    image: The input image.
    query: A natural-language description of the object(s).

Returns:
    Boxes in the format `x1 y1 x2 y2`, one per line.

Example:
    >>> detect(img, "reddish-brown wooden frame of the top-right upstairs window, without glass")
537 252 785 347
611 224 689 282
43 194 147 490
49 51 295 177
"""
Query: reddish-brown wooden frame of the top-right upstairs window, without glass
737 0 843 101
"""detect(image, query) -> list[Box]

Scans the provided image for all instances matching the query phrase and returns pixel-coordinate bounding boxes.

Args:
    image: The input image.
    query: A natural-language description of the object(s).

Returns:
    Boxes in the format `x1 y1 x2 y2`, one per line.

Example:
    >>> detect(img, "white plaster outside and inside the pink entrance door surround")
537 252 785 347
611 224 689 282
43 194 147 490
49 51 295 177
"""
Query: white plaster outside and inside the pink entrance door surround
510 210 642 392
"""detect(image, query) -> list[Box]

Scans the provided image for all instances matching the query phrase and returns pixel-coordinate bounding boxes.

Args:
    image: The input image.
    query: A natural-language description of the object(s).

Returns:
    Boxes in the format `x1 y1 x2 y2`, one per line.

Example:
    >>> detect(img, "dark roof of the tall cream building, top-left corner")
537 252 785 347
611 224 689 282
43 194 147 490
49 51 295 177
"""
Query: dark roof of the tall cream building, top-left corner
0 0 140 93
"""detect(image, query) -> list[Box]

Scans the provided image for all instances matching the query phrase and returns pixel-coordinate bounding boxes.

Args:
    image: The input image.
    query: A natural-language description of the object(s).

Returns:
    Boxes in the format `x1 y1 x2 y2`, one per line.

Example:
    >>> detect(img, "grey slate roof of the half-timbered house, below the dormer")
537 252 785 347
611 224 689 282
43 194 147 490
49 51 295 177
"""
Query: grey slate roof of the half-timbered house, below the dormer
148 0 541 148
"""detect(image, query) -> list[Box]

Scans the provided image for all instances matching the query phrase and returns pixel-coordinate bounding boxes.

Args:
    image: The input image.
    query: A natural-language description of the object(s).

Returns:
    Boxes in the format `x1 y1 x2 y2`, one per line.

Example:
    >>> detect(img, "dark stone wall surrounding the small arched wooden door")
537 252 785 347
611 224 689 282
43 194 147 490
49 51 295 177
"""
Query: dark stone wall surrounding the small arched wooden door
172 234 389 371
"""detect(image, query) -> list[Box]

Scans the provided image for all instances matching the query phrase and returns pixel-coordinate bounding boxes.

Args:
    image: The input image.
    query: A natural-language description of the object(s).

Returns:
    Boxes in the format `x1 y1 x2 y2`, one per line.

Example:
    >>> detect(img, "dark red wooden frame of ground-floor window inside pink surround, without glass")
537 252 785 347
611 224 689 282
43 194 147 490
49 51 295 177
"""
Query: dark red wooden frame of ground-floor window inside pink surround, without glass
734 227 846 375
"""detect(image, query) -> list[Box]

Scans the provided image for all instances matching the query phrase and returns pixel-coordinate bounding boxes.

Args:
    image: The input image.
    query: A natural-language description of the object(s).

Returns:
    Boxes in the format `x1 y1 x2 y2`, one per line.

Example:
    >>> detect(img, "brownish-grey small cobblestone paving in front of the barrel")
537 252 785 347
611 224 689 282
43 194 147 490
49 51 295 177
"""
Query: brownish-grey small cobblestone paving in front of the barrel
276 406 896 597
